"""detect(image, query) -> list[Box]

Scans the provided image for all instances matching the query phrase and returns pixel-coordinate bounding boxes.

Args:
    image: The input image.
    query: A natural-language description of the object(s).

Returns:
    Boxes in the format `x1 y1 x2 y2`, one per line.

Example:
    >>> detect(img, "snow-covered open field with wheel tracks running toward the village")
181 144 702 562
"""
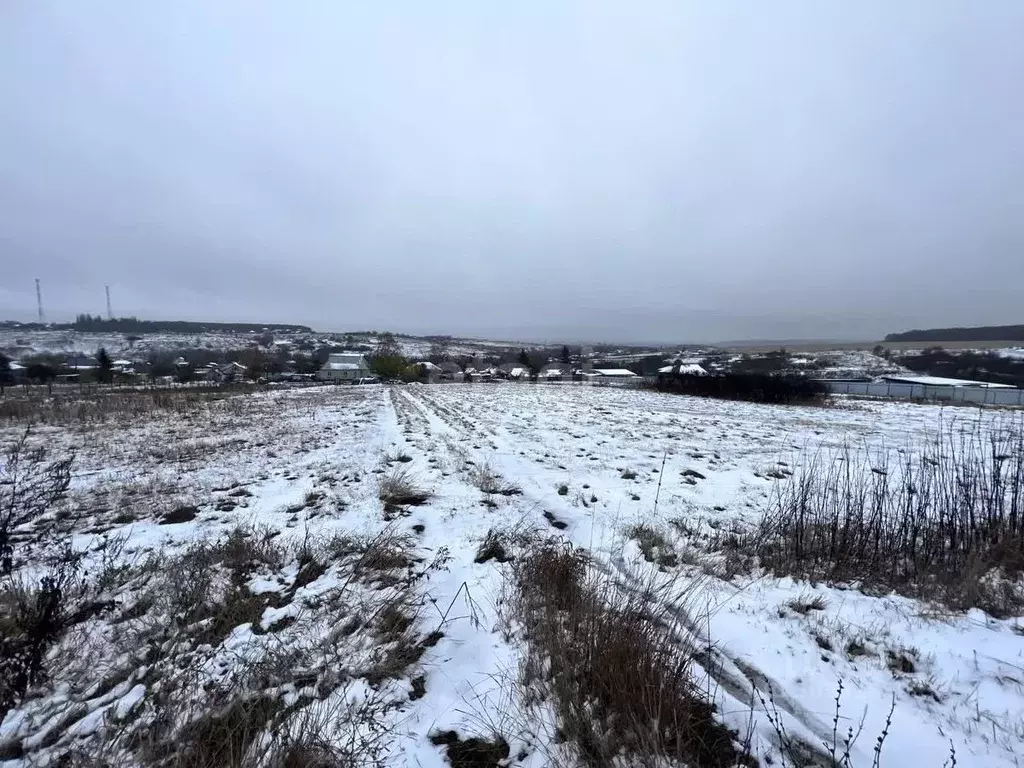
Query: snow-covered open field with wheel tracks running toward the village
0 384 1024 766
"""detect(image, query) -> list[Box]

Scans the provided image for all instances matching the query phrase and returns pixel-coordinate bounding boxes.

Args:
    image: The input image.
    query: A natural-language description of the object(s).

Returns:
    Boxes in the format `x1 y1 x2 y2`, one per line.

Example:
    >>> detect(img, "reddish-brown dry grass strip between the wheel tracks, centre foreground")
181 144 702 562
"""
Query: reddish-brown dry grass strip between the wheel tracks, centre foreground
510 540 749 768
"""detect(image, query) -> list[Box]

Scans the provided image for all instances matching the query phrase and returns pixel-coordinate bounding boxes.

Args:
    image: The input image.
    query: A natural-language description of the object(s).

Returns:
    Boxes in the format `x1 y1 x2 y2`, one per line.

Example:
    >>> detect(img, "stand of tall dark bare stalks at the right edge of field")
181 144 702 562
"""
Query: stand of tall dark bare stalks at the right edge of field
745 418 1024 615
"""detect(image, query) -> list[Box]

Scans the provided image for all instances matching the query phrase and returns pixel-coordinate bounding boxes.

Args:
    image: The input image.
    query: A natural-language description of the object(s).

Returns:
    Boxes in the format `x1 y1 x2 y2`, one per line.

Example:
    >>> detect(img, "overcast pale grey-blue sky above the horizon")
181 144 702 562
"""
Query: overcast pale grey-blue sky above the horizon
0 0 1024 341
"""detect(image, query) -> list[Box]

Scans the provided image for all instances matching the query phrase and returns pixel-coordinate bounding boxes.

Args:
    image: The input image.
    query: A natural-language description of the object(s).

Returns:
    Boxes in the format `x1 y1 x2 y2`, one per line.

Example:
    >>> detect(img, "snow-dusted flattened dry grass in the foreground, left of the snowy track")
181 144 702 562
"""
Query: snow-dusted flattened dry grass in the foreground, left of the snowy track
3 527 443 768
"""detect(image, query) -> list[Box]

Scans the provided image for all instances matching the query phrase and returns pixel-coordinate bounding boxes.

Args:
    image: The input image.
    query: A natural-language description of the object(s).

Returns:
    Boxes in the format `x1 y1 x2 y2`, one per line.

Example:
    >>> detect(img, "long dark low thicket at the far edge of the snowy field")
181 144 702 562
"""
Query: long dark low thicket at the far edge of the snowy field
642 373 828 404
